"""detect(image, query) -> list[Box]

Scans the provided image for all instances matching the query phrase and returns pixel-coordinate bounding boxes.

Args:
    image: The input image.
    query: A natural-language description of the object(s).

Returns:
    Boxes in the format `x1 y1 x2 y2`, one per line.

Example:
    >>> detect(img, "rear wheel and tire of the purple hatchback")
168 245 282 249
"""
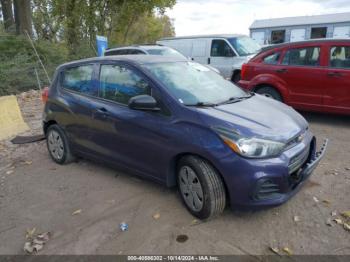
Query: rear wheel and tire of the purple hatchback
46 124 75 165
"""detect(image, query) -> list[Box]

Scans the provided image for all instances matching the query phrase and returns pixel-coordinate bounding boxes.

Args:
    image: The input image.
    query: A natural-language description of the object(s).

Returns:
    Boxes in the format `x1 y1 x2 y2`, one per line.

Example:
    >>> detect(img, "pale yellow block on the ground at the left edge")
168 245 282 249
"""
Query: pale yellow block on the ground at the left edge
0 96 29 140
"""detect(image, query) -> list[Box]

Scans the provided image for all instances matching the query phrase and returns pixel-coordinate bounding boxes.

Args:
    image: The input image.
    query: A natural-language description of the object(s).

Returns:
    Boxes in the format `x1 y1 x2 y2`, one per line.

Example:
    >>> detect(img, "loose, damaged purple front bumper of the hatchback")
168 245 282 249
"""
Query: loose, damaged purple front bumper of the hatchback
219 133 328 208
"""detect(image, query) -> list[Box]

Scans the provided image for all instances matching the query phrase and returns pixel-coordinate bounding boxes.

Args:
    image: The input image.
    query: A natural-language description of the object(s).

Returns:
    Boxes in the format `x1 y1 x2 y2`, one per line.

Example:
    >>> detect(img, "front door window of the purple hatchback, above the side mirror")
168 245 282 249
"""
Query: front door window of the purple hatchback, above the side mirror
99 65 151 104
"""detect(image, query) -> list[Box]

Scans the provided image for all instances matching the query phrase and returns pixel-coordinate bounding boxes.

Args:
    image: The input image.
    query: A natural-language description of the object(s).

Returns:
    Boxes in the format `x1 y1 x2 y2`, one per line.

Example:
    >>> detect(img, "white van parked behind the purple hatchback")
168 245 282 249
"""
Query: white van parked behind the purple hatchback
157 35 261 83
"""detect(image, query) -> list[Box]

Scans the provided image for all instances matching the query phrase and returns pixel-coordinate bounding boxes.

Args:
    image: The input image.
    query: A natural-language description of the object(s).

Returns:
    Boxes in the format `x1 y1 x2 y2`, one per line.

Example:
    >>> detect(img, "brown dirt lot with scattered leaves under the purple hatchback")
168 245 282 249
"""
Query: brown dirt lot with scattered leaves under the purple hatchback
0 92 350 254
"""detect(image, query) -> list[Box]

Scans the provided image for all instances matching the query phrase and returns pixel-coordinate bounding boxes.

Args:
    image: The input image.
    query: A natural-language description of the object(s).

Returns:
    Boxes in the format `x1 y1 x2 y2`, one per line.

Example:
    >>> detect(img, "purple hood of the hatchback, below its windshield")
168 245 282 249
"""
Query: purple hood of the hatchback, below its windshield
197 95 308 142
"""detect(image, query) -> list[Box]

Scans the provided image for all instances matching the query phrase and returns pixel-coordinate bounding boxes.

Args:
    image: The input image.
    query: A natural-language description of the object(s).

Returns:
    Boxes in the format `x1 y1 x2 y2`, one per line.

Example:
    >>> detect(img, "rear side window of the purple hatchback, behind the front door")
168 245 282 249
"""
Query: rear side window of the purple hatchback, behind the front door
62 65 97 96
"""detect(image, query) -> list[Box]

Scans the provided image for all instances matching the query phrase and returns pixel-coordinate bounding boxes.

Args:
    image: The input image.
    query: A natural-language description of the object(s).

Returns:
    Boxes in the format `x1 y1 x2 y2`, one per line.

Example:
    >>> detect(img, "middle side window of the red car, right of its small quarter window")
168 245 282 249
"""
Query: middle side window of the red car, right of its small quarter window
282 47 320 66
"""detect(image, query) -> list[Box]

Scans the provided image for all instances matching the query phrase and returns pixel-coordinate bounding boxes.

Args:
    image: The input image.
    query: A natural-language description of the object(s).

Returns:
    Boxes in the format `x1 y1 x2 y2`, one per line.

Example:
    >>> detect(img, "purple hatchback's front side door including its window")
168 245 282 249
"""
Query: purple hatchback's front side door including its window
92 62 171 180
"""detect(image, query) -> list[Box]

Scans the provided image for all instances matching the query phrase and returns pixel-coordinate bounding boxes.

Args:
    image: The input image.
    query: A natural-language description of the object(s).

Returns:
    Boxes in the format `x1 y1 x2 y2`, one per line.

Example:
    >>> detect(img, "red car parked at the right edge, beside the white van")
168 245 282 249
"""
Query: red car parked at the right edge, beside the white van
239 39 350 114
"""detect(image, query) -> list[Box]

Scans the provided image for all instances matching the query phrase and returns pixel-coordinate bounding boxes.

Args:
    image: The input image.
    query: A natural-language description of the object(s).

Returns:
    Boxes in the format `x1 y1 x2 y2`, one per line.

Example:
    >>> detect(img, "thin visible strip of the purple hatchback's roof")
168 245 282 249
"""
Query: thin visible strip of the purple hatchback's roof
60 55 188 67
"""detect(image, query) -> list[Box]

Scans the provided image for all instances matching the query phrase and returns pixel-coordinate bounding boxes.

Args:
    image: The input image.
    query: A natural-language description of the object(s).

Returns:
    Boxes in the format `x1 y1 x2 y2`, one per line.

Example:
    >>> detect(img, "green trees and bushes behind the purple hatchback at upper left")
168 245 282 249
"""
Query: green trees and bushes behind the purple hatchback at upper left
0 0 176 96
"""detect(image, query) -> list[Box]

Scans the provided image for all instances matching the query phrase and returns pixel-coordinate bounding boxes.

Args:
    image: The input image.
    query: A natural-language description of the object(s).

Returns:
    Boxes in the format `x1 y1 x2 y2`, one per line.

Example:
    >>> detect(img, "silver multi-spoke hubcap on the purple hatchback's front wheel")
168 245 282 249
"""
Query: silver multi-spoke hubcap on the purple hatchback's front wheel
179 166 203 211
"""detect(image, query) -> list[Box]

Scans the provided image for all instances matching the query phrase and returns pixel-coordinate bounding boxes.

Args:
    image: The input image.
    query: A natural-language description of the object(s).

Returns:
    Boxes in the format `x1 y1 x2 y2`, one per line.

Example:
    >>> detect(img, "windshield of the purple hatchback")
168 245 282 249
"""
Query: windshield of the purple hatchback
144 62 249 106
